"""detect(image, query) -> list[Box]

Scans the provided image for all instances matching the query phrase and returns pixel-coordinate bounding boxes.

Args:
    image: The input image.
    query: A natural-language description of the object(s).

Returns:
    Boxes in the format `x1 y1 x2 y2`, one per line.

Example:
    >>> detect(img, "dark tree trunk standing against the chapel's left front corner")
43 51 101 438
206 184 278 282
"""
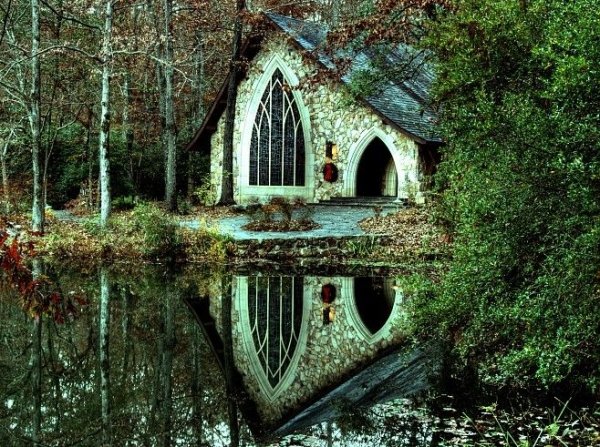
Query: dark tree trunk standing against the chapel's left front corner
219 0 246 205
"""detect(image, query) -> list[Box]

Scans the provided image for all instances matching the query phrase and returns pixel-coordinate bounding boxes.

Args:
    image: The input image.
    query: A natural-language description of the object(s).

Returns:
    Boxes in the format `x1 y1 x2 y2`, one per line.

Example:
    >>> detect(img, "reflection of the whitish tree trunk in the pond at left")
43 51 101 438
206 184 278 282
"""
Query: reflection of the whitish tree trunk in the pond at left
99 268 112 446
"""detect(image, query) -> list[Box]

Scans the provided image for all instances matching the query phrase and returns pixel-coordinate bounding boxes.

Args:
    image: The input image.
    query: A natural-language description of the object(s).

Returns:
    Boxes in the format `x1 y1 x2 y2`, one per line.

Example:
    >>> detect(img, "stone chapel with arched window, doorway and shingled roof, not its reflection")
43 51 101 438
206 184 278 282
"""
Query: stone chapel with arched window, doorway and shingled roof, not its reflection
188 13 442 204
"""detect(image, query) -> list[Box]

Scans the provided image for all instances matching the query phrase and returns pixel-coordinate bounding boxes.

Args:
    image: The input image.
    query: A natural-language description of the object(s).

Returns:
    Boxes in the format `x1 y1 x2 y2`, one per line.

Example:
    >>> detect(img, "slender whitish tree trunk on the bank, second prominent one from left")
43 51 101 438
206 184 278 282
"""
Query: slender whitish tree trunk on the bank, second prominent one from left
99 0 113 228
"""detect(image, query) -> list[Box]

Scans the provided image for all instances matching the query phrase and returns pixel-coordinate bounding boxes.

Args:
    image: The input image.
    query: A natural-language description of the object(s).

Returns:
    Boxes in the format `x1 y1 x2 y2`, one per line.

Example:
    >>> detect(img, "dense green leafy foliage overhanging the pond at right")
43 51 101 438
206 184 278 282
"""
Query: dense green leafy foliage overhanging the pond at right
415 0 600 390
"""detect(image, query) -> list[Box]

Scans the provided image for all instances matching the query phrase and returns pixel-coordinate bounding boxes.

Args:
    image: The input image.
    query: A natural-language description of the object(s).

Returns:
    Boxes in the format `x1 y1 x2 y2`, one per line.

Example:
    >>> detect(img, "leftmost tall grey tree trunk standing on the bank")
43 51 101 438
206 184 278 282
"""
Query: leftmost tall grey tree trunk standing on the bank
29 0 44 232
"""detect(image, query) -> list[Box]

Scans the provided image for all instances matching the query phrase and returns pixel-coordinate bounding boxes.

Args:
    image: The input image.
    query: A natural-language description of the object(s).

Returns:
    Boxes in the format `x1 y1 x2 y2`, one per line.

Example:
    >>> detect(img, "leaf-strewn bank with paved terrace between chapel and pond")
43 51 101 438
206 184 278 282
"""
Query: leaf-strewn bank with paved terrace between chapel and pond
7 205 449 265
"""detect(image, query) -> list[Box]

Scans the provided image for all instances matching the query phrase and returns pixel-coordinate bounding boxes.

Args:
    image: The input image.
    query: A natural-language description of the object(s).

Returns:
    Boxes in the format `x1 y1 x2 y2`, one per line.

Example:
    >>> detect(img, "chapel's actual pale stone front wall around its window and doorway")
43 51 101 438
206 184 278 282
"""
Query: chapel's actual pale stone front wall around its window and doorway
211 35 420 203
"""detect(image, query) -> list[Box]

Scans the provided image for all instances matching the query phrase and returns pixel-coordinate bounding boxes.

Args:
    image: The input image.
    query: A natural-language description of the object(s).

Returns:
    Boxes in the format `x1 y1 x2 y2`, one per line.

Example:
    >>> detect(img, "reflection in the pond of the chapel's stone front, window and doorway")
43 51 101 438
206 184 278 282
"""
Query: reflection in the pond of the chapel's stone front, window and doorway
199 276 402 425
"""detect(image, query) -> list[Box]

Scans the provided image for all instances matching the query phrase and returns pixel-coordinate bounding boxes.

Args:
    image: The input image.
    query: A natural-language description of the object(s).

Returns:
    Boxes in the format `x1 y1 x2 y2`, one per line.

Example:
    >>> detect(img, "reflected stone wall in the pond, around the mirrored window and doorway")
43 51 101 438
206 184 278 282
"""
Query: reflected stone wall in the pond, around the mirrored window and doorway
211 276 403 423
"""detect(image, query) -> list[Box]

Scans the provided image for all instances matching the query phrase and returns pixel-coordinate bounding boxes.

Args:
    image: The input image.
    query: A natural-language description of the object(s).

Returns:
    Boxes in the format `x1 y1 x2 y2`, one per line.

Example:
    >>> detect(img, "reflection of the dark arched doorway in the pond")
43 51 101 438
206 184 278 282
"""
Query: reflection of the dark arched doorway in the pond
354 277 396 336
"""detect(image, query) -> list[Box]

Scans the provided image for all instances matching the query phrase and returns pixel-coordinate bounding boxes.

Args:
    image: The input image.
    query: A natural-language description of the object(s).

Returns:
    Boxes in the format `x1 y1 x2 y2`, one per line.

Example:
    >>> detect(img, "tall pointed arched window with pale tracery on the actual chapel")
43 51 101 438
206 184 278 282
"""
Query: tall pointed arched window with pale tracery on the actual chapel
249 69 305 186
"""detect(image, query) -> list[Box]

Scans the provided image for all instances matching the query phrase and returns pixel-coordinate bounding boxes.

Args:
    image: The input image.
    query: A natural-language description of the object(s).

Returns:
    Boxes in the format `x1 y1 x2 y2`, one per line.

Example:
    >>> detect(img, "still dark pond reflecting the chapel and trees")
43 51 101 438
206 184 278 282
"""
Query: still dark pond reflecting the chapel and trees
0 265 596 446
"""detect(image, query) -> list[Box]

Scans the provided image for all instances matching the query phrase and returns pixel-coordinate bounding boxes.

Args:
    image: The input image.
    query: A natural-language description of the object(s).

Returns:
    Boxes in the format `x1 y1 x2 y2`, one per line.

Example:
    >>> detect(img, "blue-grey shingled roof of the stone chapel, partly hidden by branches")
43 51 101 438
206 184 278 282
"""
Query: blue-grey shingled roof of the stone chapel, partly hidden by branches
188 12 442 149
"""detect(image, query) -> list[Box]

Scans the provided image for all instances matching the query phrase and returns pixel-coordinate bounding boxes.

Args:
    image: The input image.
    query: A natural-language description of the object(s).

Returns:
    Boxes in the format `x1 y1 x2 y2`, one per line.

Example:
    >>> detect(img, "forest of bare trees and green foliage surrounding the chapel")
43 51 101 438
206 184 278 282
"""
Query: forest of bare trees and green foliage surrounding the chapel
0 0 600 416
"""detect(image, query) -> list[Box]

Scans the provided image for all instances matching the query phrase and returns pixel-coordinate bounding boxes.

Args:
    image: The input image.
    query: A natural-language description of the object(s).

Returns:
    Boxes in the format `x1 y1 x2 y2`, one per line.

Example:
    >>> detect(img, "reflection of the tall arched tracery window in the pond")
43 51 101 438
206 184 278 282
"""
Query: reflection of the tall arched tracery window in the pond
248 276 304 396
